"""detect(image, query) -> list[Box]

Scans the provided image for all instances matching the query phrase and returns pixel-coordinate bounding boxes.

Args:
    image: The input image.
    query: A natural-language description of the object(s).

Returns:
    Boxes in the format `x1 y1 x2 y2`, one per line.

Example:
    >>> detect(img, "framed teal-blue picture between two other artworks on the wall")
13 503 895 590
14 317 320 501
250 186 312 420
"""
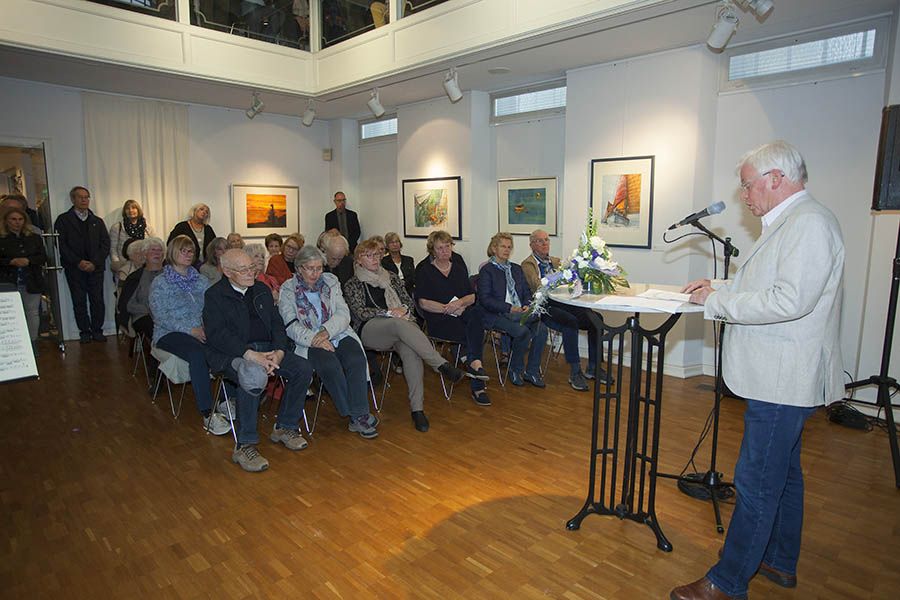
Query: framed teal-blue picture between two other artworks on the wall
497 177 557 235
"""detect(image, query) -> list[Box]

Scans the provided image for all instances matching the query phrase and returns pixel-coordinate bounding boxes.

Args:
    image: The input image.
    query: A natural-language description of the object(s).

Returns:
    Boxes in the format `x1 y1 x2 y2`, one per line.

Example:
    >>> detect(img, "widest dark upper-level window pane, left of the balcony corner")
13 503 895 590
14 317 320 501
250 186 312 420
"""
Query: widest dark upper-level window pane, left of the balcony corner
192 0 309 50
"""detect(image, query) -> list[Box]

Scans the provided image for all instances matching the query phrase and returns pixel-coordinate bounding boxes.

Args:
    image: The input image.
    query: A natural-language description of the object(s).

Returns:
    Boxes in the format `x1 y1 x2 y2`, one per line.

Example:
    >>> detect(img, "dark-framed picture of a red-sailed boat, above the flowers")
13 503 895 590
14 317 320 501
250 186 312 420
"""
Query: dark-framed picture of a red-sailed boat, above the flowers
591 156 654 248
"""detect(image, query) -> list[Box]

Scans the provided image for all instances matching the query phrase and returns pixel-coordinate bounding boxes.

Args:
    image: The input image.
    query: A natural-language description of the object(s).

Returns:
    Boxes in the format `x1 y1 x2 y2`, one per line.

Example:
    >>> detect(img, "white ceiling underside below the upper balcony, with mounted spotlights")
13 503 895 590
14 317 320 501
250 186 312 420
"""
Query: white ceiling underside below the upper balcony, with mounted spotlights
0 0 898 119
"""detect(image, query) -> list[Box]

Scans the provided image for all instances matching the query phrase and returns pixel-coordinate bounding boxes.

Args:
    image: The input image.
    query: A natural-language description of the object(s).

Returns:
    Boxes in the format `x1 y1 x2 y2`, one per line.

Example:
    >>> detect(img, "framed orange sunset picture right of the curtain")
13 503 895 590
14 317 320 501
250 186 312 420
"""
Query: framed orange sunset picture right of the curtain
231 183 300 238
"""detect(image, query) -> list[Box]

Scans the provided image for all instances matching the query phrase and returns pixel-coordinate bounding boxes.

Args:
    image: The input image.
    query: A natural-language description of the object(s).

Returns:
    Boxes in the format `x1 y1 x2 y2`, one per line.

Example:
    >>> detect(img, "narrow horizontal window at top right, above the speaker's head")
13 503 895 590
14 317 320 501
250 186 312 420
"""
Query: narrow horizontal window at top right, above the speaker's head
721 21 887 90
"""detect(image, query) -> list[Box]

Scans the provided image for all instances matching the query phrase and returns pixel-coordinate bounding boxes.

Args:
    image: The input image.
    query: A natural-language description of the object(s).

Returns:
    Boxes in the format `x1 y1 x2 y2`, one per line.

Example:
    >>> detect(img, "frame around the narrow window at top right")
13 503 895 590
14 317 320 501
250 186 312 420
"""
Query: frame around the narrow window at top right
719 16 891 93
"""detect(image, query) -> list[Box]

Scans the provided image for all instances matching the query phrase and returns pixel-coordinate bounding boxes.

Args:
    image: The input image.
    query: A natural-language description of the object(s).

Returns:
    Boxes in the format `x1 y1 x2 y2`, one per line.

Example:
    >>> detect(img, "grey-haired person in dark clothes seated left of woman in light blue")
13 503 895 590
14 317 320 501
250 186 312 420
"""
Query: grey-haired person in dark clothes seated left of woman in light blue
116 238 166 341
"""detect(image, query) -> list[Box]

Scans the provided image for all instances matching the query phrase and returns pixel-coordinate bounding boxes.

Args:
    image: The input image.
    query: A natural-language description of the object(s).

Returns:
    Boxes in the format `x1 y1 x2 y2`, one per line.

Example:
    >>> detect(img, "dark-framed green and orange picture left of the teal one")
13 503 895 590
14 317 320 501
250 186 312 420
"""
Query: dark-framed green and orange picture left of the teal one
403 177 462 240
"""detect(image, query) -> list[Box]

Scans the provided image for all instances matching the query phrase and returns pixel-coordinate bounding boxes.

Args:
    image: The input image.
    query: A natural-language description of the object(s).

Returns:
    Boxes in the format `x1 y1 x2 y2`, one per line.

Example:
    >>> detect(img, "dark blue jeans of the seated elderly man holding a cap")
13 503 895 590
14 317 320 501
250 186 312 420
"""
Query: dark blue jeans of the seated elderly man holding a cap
225 342 312 446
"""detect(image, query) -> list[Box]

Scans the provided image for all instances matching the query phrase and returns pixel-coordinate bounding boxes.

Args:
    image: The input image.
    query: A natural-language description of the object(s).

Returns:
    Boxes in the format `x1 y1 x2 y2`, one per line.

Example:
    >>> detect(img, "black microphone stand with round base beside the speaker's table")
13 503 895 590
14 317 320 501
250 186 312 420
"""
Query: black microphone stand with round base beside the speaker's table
658 221 739 533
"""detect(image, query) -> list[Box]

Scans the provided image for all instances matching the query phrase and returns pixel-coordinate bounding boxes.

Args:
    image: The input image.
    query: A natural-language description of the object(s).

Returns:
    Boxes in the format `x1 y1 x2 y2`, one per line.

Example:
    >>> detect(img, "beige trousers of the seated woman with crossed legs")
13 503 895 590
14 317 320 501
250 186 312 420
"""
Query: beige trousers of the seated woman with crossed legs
362 317 447 411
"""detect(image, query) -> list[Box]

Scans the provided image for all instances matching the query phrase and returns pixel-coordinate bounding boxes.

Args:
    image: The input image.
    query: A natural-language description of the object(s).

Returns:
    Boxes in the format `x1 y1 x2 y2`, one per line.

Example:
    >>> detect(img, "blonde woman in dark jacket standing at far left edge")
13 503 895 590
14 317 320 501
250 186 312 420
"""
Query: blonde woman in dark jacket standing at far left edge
0 204 47 350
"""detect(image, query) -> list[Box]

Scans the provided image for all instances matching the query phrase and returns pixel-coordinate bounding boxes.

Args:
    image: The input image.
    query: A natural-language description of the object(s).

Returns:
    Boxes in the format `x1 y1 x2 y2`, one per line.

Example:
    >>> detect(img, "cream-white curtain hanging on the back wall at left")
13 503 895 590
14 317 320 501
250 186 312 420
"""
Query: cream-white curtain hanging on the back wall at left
82 92 190 242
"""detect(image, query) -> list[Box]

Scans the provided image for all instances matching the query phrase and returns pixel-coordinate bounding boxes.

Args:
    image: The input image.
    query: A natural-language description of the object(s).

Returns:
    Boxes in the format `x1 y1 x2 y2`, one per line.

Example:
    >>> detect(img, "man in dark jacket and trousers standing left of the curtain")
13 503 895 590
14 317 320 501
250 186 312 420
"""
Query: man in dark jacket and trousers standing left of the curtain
56 185 109 344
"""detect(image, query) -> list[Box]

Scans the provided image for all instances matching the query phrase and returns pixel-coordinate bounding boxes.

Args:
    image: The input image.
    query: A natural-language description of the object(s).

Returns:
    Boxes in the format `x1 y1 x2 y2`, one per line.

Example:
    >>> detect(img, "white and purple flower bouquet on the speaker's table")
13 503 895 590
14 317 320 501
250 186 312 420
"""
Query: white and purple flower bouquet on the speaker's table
522 209 628 323
